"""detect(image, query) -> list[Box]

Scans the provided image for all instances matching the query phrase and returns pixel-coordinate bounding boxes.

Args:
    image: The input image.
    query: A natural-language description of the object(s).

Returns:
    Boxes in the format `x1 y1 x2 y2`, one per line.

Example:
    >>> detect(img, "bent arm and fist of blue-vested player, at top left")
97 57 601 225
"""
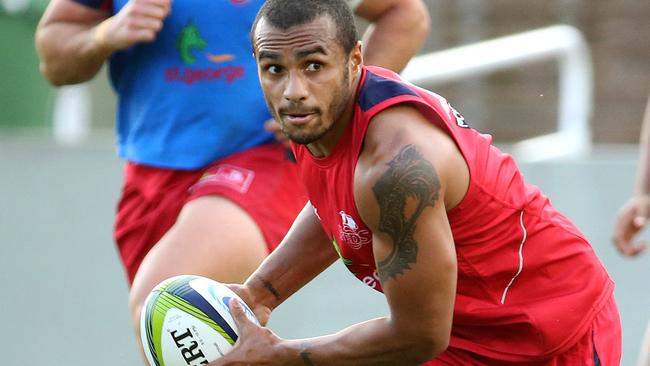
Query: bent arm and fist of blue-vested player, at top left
36 0 170 85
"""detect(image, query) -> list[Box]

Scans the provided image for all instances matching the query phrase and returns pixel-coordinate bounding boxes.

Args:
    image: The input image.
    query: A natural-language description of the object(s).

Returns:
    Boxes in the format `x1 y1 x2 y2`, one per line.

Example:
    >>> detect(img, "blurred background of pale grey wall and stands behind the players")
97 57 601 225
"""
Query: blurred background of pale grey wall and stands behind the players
0 0 650 366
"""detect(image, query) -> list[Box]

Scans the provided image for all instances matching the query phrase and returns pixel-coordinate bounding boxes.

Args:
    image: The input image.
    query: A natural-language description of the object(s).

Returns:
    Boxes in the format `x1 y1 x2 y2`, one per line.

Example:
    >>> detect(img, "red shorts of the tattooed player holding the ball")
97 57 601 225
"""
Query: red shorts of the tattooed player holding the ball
424 295 622 366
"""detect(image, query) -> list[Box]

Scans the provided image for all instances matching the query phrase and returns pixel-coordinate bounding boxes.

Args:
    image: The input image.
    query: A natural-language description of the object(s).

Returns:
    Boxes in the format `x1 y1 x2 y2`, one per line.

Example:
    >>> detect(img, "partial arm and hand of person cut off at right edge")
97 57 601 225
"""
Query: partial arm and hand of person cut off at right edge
613 93 650 256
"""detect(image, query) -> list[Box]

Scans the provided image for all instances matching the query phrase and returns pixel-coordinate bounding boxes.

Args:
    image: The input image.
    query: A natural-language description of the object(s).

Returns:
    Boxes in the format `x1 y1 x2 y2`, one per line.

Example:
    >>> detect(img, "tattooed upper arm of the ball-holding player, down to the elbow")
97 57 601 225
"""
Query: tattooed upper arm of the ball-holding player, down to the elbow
358 145 456 340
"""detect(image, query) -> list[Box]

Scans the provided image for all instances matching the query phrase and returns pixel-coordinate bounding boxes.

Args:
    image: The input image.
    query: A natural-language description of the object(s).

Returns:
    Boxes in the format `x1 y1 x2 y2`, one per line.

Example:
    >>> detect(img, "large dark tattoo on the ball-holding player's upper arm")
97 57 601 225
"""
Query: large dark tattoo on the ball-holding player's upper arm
372 145 440 283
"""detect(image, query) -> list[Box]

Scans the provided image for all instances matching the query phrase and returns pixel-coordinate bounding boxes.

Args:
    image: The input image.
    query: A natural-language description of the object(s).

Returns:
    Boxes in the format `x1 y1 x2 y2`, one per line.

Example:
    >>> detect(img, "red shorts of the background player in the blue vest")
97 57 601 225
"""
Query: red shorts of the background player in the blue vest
114 144 307 283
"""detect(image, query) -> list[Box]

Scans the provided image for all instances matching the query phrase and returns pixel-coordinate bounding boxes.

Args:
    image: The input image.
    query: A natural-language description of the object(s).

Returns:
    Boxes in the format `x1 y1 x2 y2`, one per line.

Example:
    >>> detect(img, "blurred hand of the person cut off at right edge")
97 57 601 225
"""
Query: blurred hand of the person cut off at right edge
613 195 650 257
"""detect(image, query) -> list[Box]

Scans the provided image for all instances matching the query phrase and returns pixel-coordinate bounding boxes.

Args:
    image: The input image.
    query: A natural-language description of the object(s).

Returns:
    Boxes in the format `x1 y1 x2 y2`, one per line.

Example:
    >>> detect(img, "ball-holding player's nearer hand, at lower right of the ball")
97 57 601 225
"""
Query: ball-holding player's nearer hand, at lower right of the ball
208 298 283 366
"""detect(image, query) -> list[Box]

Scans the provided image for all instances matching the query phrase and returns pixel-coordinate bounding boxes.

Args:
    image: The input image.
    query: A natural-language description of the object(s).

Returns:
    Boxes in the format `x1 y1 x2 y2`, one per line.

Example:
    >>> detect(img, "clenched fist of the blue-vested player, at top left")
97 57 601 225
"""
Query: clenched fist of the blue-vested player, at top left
101 0 171 50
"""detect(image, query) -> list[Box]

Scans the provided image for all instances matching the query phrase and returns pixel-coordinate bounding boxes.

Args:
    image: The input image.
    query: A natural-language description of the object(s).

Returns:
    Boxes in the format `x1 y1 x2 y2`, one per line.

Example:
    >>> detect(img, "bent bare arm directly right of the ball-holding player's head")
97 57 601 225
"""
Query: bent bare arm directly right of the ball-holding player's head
363 0 430 72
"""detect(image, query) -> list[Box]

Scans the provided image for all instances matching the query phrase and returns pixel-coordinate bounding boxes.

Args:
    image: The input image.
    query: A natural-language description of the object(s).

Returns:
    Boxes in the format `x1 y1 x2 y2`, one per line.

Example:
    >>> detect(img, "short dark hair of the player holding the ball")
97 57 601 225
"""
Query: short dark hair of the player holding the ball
251 0 359 54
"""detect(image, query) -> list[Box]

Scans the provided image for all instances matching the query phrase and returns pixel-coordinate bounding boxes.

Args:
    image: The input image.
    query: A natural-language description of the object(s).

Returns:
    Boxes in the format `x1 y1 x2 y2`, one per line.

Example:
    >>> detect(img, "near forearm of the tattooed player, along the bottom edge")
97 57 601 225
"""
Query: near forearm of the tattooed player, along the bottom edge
284 318 448 366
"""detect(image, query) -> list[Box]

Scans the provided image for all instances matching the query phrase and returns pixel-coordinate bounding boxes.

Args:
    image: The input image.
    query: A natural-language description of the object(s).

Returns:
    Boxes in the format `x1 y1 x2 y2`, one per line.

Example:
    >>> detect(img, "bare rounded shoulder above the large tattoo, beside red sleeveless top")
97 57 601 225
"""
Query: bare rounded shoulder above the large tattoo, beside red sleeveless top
355 103 469 215
